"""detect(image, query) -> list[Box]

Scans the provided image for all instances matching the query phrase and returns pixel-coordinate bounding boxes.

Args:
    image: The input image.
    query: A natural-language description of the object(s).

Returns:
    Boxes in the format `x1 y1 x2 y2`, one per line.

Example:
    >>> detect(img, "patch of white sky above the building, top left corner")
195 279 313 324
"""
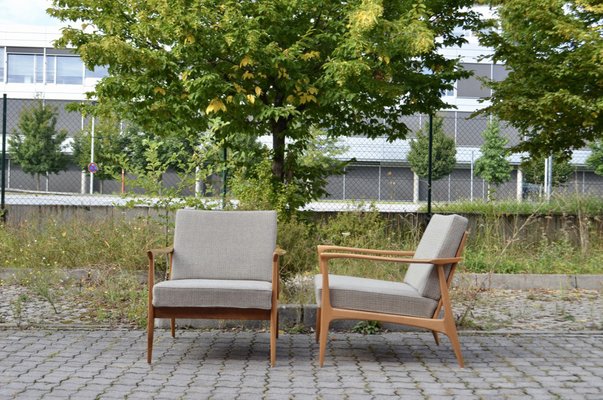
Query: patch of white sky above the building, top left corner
0 0 60 27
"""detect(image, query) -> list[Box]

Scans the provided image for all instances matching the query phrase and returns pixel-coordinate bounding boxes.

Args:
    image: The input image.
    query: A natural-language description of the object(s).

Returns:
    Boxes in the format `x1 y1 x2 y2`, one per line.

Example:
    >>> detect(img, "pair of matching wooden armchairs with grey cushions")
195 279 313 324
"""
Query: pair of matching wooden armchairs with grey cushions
147 210 467 367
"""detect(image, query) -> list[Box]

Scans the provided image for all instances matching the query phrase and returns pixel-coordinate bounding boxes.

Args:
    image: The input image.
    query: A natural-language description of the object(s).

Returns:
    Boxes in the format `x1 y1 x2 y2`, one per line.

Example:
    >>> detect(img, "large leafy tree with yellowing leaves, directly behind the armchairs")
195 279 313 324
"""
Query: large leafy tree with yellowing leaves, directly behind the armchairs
50 0 481 206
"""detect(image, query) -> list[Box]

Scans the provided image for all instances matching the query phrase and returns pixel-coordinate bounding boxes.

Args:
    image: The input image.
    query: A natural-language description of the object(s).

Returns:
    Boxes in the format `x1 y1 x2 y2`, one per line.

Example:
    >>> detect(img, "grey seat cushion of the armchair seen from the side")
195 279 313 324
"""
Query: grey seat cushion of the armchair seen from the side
314 274 438 318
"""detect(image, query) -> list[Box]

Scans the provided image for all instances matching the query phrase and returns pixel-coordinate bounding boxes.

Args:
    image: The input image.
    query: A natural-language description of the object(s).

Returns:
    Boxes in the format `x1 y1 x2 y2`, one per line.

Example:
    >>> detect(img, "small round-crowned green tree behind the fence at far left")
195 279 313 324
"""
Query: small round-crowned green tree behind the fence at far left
8 100 69 190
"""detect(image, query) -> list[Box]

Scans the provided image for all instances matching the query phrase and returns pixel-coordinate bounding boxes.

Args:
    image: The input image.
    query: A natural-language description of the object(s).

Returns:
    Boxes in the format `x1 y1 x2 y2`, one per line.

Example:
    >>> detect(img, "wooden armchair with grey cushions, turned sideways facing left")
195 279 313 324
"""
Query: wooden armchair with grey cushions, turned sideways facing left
315 215 467 367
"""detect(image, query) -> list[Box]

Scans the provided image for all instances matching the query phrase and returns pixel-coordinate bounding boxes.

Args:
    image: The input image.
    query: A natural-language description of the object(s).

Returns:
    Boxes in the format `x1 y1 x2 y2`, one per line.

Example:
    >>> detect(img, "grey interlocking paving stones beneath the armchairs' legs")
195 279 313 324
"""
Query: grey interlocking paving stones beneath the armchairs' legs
0 329 603 399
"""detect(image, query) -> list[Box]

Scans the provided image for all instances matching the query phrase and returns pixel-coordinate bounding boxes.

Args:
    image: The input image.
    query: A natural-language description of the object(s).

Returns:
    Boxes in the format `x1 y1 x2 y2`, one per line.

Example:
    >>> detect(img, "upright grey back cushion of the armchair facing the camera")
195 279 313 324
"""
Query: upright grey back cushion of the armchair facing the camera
172 210 276 282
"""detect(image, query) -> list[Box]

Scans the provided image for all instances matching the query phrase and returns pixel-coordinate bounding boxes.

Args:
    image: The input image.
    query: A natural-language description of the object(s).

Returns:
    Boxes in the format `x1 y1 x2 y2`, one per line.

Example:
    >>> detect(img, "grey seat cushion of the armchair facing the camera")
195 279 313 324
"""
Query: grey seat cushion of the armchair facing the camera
153 279 272 310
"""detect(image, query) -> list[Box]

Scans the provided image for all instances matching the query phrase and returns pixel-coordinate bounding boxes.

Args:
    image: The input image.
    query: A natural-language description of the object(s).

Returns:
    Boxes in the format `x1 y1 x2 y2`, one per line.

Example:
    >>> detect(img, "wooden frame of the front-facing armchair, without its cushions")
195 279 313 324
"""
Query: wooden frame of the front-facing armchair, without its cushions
147 247 285 367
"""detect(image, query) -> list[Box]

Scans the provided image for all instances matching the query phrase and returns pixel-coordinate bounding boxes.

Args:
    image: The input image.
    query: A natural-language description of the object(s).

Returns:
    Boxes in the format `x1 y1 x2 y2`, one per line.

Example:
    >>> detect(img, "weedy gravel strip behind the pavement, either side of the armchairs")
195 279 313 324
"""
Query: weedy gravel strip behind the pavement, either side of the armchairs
0 282 603 331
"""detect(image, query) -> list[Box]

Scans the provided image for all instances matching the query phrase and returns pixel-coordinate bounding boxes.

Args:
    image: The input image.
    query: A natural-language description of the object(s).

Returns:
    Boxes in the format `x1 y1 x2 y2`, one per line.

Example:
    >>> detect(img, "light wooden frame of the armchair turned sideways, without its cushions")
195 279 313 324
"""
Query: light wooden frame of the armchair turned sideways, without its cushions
316 232 468 368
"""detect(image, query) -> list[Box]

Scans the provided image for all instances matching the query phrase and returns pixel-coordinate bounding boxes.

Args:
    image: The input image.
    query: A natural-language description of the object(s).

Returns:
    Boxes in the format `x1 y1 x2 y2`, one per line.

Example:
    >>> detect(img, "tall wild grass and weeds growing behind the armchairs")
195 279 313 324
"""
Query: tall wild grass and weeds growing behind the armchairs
0 199 603 327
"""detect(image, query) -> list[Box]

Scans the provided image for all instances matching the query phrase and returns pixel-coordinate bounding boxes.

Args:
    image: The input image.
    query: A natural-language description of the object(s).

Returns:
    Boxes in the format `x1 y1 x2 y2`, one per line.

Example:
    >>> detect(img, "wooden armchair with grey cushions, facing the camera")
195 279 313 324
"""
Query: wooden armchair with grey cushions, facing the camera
147 210 282 366
